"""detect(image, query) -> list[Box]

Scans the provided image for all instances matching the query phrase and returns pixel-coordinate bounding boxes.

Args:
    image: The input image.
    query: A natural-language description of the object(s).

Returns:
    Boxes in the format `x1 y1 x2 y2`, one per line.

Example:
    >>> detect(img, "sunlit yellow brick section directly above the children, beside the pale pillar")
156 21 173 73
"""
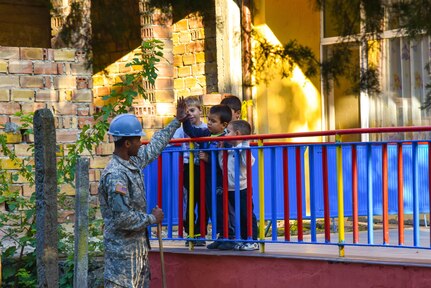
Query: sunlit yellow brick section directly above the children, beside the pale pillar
172 14 218 100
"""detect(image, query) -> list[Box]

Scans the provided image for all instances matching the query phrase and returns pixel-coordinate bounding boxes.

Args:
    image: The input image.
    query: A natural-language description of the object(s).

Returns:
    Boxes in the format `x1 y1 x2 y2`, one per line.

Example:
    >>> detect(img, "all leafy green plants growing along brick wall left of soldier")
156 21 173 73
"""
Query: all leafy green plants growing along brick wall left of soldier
0 40 163 287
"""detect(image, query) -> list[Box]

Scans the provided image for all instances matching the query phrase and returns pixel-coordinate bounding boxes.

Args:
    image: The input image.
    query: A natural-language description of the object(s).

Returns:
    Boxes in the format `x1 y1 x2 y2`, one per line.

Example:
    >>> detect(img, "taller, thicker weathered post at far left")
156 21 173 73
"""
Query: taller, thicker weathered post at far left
33 109 58 288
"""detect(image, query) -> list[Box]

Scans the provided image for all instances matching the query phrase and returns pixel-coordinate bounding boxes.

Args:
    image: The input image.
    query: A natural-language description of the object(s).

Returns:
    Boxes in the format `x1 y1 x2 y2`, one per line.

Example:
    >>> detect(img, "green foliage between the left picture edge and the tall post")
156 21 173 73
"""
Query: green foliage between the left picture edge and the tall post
0 115 36 287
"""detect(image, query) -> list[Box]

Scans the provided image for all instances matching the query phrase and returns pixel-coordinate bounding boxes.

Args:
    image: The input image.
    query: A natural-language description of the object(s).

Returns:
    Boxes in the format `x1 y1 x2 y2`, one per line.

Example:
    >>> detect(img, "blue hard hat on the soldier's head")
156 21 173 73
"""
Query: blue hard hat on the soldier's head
108 114 145 137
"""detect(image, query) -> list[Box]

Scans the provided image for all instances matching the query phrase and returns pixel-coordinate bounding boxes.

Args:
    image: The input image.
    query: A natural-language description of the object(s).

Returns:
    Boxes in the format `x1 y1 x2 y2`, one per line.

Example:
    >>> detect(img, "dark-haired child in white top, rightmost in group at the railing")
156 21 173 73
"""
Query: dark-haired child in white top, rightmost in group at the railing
219 120 259 251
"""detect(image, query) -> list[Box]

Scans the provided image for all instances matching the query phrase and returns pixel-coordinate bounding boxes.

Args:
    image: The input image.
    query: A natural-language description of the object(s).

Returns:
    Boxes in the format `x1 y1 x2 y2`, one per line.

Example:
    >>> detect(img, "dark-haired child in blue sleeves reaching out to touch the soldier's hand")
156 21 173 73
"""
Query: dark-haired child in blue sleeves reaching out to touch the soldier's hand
183 105 234 249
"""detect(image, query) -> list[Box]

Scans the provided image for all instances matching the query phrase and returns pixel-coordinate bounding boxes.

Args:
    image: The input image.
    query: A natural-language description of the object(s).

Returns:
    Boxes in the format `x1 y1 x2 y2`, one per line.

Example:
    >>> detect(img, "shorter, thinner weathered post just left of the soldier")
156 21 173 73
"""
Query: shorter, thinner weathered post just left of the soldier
73 158 90 288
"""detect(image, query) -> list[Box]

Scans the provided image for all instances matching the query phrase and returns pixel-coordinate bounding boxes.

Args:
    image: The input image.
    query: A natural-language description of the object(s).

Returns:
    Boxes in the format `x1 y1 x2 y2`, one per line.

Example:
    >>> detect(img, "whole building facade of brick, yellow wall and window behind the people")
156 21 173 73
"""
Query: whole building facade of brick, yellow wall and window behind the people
0 0 431 207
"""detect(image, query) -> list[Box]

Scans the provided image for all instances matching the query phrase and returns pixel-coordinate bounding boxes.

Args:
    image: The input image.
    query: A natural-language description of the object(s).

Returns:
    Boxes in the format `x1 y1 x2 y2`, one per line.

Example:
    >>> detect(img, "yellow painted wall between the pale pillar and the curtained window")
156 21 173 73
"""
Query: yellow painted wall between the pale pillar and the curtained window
253 0 322 141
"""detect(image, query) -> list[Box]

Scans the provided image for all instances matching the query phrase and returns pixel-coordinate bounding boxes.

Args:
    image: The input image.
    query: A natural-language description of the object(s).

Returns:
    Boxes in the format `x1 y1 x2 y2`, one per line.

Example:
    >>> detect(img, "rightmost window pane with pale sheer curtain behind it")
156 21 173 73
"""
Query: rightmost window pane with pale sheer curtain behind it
376 37 430 140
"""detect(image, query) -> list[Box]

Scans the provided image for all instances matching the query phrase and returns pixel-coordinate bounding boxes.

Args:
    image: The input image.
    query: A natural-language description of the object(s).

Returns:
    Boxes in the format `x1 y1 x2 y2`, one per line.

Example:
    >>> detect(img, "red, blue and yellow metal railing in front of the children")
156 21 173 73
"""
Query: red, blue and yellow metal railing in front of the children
144 126 431 256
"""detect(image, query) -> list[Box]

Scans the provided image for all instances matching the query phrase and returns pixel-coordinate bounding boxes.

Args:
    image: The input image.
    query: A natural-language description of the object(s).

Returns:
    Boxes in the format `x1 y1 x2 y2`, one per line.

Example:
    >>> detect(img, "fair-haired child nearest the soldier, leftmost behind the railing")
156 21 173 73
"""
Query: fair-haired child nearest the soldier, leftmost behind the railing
173 96 207 246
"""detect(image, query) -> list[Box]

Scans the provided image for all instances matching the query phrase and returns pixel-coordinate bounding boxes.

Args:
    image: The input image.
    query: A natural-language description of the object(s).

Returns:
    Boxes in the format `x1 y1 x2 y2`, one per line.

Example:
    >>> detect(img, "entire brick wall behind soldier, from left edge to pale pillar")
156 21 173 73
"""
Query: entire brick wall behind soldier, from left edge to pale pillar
0 0 228 216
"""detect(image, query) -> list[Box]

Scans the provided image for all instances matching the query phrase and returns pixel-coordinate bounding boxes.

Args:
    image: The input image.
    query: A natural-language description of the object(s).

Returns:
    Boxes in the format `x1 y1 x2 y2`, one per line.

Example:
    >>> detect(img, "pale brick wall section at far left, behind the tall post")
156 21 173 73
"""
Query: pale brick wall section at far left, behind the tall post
0 47 94 209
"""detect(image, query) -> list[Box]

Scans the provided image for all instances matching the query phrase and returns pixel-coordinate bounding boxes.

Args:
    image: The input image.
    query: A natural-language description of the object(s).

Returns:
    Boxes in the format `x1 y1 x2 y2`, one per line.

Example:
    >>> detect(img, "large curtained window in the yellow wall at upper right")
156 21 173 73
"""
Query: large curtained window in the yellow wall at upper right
321 0 431 141
